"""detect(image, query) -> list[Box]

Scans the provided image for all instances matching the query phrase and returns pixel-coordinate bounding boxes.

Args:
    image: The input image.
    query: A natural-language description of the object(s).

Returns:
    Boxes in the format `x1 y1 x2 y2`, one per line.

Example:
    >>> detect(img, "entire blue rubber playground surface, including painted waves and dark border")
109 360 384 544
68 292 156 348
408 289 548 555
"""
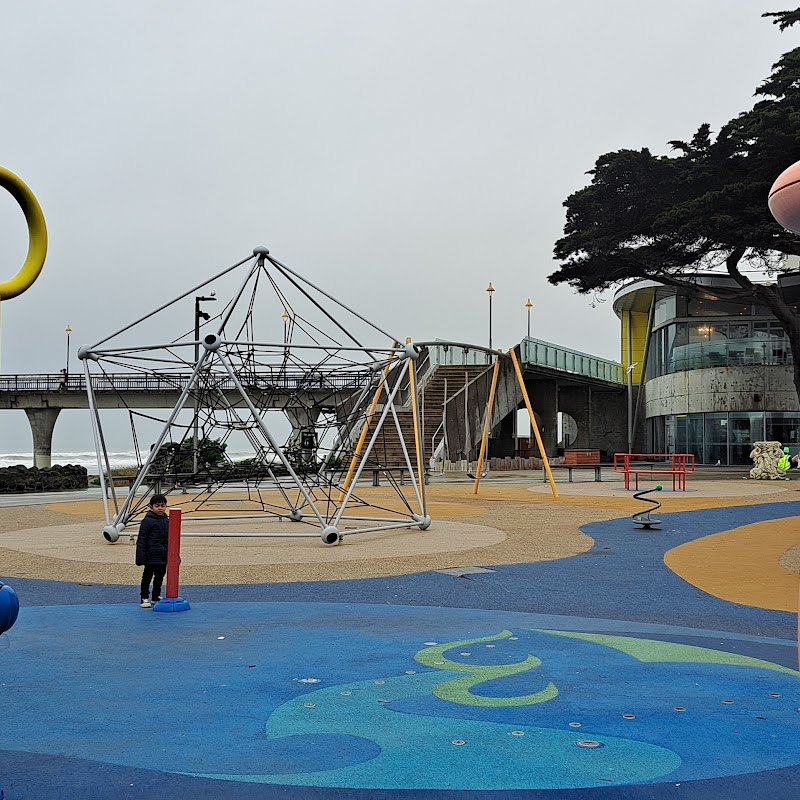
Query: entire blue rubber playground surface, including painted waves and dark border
0 503 800 800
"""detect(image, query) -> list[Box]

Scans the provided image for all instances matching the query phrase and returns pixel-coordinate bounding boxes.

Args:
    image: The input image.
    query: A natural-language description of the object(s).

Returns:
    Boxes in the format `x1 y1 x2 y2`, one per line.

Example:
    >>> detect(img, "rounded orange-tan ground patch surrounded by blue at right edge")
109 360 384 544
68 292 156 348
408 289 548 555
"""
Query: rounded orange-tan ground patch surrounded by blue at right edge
664 517 800 612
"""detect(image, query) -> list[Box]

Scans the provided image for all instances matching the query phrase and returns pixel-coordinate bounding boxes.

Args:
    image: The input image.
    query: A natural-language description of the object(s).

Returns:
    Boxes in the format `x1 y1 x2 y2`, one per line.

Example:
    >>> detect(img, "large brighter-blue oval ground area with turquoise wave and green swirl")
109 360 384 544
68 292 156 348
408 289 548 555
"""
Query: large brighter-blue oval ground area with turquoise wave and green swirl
0 602 800 791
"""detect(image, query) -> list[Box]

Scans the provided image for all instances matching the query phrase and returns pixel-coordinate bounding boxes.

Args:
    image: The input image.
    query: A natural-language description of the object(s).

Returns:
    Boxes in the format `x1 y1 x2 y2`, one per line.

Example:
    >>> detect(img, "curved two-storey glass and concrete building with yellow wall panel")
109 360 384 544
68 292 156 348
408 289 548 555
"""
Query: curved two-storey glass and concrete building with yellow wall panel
614 273 800 464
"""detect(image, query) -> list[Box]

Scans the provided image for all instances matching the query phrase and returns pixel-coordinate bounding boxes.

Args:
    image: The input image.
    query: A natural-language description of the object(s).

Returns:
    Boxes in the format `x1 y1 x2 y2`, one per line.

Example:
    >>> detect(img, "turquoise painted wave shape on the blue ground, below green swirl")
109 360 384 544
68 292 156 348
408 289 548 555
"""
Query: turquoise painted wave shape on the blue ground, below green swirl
192 672 681 789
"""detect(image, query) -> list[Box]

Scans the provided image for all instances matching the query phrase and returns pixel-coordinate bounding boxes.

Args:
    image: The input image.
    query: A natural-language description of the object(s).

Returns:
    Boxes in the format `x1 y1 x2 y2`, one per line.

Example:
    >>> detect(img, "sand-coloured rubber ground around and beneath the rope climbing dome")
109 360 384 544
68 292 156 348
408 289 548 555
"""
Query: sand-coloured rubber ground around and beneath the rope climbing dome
0 474 798 592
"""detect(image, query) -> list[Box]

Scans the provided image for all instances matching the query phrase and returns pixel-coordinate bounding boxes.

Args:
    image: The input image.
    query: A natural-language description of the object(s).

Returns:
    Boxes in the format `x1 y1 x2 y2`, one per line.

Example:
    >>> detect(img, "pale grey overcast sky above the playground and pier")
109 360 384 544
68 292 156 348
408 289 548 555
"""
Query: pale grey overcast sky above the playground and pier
0 0 798 451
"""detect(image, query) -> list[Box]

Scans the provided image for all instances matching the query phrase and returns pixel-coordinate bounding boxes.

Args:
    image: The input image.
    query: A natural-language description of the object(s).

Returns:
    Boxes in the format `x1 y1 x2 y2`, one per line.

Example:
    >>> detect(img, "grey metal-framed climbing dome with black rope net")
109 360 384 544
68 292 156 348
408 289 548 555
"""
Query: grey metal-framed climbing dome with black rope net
78 247 431 544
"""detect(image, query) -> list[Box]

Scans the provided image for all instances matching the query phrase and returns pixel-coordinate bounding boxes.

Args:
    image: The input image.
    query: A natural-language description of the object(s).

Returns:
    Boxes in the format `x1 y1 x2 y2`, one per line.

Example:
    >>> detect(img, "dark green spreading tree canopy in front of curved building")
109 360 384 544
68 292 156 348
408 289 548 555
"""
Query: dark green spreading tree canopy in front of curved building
548 8 800 308
